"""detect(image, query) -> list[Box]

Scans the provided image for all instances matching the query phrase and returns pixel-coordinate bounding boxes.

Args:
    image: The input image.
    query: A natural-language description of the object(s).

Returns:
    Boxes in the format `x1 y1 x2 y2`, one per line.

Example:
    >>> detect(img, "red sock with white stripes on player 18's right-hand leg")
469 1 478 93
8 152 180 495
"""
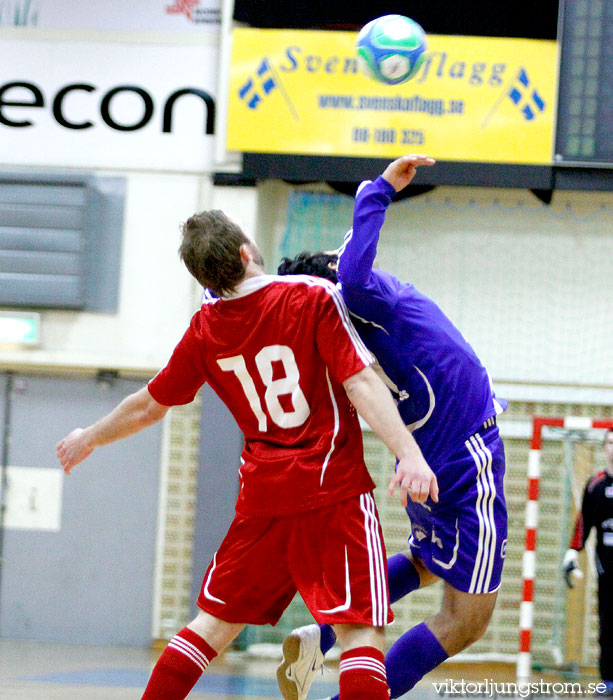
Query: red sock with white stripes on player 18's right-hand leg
339 647 390 700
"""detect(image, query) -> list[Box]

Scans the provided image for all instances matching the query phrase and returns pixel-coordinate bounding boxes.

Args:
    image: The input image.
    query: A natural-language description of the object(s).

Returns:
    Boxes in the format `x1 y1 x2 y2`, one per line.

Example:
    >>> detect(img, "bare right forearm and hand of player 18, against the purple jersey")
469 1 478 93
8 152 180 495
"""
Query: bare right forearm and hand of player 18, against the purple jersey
343 367 438 506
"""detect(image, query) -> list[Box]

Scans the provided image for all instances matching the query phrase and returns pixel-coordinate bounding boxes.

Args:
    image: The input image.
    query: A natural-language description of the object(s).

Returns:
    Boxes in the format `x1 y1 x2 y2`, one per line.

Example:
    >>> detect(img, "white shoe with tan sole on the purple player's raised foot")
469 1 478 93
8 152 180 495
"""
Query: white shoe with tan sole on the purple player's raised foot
277 625 324 700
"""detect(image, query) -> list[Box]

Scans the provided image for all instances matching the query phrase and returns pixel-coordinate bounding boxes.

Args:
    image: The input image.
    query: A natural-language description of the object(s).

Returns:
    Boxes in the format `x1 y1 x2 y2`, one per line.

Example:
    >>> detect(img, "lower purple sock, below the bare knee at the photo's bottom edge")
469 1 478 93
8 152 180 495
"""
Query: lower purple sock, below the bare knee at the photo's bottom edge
385 622 448 698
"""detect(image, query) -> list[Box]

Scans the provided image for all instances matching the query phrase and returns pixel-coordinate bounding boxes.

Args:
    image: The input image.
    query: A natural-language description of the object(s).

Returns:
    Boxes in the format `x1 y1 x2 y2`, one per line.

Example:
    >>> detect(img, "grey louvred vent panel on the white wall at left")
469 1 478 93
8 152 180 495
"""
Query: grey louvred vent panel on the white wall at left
0 173 125 313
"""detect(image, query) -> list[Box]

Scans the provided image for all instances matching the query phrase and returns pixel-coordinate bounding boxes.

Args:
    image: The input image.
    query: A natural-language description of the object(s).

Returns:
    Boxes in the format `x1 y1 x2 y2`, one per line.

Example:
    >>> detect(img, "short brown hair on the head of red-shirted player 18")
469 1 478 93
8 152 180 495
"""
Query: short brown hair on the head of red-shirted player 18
179 209 252 296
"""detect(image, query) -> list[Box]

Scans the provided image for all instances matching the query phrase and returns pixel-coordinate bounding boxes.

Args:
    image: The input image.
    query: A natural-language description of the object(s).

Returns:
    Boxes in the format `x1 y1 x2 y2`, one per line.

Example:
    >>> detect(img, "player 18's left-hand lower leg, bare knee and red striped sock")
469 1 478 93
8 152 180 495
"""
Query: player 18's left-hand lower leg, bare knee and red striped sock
142 610 245 700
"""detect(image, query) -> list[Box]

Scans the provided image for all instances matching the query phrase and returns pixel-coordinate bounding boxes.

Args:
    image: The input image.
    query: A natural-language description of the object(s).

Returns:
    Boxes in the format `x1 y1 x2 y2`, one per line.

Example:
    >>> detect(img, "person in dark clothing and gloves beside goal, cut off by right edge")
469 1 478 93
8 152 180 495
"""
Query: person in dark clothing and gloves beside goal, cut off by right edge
563 429 613 696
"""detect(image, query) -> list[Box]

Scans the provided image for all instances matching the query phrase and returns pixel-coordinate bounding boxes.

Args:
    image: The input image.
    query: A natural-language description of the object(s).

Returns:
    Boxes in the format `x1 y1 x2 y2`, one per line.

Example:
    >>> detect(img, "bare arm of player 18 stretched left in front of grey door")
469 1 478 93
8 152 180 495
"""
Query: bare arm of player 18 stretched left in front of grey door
55 387 169 474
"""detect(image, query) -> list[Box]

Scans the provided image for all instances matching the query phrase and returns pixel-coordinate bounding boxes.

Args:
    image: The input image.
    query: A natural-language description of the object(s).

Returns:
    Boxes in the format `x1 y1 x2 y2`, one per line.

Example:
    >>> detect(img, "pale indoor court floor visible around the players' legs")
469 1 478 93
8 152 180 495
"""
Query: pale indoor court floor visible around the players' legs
0 639 595 700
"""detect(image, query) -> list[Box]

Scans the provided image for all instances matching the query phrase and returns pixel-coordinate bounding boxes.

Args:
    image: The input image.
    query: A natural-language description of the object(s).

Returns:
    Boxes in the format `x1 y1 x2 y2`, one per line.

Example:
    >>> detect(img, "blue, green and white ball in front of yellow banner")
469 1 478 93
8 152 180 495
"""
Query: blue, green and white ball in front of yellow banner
357 15 426 85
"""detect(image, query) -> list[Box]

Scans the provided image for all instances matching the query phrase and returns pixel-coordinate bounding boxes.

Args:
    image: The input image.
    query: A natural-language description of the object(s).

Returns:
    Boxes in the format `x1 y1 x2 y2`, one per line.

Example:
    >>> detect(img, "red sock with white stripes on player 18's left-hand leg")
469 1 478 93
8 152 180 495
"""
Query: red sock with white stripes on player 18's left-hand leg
142 627 217 700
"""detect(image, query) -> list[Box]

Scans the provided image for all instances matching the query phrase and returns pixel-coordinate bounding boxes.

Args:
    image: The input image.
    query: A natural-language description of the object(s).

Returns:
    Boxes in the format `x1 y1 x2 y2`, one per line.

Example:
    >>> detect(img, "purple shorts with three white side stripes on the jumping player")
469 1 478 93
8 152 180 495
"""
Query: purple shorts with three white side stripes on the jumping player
406 423 507 593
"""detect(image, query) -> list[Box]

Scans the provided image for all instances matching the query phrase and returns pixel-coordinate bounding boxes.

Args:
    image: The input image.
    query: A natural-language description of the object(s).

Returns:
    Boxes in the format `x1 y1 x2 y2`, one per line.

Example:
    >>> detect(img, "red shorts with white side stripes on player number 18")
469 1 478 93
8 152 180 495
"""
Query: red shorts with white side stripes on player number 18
198 493 393 626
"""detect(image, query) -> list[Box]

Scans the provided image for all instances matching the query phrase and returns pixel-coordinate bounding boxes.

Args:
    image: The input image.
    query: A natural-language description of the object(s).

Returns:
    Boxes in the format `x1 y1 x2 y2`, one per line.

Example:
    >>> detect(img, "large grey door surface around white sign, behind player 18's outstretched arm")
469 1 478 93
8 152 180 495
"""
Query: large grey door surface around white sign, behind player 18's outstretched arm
0 377 161 647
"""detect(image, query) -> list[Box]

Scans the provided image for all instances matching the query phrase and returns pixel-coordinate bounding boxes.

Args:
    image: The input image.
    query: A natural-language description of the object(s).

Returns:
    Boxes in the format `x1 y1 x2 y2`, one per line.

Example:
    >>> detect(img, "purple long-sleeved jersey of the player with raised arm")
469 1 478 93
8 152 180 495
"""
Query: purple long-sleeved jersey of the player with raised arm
338 177 506 473
